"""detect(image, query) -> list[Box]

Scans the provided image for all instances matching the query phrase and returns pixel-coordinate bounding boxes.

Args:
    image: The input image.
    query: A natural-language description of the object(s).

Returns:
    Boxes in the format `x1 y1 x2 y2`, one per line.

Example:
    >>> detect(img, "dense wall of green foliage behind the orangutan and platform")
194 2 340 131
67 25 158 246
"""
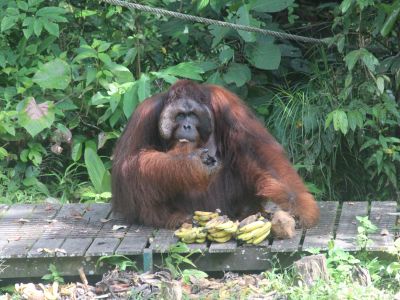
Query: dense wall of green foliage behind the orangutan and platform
0 0 400 201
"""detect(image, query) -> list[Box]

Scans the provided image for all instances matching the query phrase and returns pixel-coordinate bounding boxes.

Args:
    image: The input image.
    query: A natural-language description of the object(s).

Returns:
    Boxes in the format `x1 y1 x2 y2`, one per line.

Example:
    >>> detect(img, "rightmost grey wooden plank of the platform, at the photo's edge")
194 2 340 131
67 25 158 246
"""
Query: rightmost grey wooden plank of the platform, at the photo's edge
367 201 397 251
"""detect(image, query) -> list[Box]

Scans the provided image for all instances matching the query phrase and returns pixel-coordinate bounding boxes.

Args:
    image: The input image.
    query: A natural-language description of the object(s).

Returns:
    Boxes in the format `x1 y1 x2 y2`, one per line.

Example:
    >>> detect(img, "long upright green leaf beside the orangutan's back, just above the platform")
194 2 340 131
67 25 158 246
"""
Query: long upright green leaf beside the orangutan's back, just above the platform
84 141 111 193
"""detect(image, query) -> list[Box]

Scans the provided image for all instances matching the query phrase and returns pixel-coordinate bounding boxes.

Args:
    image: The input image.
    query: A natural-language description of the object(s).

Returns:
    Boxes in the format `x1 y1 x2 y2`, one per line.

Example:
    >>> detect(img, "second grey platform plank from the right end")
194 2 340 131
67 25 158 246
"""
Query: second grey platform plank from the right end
335 202 368 251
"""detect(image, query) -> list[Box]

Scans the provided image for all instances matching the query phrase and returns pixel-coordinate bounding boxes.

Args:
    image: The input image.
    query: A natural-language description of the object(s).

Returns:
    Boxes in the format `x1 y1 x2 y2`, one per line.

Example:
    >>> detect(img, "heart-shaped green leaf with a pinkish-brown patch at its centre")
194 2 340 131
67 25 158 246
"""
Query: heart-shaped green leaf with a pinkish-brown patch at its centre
17 97 54 137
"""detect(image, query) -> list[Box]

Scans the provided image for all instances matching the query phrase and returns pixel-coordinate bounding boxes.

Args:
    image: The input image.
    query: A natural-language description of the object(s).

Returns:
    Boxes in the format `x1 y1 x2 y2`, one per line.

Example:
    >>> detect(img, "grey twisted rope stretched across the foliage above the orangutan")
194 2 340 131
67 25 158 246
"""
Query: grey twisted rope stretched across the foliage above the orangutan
101 0 328 44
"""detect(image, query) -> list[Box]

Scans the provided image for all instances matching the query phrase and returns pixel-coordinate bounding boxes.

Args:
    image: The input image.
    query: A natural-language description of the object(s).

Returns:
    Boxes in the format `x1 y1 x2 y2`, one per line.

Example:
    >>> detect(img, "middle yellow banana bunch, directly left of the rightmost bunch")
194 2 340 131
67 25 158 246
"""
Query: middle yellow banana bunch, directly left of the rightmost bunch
205 216 239 243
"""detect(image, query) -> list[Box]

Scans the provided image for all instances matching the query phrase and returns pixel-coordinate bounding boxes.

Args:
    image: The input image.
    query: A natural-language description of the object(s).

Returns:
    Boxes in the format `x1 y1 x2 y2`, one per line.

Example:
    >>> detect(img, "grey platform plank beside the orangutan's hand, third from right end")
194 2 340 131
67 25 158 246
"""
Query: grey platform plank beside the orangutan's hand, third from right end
302 201 338 250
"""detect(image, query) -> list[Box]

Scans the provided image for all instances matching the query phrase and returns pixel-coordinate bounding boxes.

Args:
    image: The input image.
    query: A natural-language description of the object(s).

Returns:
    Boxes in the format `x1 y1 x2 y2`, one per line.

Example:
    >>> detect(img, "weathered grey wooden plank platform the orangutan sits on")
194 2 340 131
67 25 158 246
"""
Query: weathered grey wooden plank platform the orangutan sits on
0 201 398 278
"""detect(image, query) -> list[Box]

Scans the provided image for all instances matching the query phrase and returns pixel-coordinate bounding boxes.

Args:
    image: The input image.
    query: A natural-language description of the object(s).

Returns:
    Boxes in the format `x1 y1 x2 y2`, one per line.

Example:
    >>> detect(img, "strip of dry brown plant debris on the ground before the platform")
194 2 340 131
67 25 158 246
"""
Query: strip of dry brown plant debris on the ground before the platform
10 270 280 300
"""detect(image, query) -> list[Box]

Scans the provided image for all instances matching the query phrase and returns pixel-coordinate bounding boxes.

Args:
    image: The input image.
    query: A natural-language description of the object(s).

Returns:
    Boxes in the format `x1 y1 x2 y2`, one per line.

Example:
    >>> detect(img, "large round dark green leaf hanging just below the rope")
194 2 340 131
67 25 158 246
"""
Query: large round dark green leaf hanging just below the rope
245 40 281 70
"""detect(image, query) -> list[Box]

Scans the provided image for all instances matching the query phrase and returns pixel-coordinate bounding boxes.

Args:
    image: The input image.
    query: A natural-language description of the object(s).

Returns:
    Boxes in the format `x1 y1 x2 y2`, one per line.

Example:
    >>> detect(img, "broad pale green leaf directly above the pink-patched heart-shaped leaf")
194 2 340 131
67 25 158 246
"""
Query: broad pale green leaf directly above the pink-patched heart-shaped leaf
32 58 71 90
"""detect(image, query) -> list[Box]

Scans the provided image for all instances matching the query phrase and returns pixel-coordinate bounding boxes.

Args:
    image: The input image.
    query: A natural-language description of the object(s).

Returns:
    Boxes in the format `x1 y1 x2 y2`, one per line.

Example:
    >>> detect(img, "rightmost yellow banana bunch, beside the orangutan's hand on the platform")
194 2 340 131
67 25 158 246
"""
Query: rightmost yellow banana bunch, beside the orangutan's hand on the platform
236 214 271 245
